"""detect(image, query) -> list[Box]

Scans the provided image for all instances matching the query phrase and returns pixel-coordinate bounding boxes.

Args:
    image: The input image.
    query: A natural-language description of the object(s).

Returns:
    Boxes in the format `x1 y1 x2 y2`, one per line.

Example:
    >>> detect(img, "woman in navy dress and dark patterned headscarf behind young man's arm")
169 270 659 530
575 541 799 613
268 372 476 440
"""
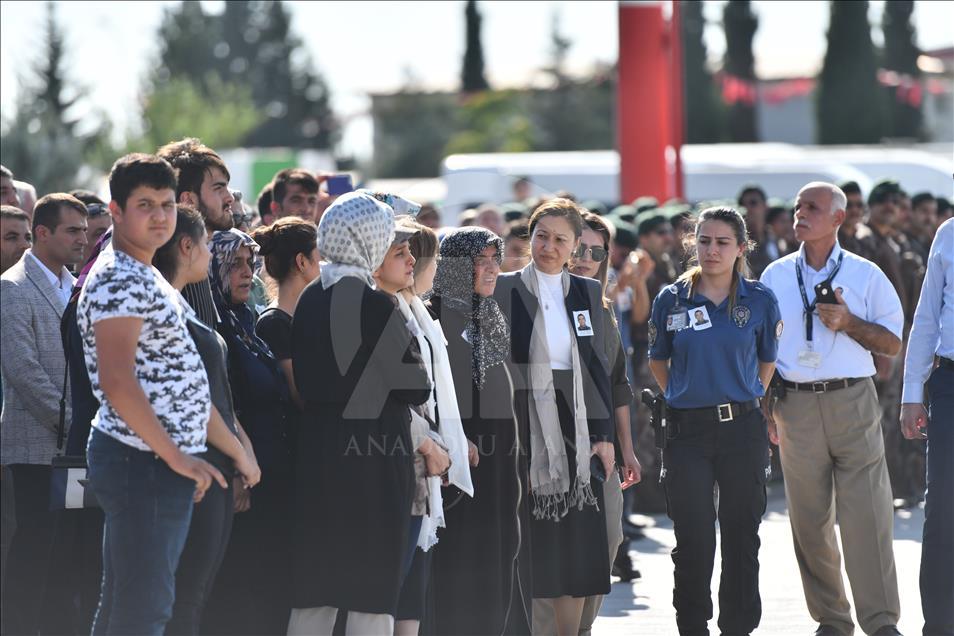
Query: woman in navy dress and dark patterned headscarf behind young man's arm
204 229 293 634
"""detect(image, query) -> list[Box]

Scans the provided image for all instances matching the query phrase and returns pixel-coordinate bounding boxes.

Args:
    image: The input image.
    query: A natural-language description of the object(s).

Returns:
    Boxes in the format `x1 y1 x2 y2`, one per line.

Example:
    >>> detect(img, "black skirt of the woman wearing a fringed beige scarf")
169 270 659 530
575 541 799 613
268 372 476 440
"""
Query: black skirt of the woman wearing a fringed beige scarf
530 370 610 598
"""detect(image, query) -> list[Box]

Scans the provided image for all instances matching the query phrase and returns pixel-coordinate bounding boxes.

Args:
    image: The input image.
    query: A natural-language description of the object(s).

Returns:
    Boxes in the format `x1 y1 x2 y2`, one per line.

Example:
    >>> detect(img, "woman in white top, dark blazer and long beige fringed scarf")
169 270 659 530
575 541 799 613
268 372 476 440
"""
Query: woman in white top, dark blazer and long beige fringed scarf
494 198 615 636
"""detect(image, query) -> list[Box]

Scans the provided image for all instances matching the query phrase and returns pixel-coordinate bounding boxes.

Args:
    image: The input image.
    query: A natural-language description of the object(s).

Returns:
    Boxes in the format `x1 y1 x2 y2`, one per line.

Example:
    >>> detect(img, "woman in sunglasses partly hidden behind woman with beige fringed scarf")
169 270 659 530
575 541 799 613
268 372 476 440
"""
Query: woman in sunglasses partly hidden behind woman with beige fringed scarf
570 212 642 633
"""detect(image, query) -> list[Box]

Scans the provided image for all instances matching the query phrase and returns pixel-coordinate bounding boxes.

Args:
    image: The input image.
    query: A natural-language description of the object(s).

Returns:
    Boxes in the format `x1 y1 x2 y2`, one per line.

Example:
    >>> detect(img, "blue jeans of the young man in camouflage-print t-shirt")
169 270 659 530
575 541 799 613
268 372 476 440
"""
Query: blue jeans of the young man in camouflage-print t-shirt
87 430 195 635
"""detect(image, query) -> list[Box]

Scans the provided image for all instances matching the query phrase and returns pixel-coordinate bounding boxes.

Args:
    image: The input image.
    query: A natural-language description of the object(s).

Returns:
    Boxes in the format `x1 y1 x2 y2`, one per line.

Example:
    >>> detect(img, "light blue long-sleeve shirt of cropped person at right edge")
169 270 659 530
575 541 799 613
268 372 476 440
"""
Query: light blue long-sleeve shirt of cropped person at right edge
901 219 954 403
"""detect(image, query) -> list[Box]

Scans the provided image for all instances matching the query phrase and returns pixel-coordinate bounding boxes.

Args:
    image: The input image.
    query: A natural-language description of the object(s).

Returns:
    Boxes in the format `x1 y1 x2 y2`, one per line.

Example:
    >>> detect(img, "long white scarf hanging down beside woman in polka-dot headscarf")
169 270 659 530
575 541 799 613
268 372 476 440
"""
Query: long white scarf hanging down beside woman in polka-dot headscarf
397 294 474 552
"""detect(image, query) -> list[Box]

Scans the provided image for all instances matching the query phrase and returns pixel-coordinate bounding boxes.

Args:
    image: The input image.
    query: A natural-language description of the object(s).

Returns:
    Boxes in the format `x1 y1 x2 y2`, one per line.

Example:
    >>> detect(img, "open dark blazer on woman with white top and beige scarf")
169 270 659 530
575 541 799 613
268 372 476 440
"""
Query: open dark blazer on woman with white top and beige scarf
494 263 618 442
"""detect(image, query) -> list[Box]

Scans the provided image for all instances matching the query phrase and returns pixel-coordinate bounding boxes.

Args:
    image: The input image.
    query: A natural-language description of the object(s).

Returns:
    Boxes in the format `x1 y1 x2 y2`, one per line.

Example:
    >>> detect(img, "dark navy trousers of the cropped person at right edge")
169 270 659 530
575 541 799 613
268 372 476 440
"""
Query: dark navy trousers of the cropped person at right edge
921 367 954 636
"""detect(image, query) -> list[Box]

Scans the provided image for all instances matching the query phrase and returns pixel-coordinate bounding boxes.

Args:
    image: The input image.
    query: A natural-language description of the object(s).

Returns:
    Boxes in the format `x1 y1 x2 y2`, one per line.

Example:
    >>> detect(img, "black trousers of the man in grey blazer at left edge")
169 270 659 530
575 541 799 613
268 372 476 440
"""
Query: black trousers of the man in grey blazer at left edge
3 464 56 634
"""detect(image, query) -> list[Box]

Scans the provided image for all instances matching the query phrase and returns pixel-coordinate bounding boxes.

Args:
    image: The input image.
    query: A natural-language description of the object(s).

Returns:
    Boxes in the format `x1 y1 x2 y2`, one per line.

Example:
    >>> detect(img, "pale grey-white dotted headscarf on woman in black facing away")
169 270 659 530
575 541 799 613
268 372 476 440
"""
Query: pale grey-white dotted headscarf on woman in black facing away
318 192 394 289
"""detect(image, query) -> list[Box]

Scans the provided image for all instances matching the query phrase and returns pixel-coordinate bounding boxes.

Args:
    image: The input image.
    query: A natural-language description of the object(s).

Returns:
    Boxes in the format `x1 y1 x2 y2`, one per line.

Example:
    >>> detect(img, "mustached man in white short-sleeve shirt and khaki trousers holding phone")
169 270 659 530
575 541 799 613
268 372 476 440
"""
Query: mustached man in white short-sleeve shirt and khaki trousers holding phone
761 182 904 636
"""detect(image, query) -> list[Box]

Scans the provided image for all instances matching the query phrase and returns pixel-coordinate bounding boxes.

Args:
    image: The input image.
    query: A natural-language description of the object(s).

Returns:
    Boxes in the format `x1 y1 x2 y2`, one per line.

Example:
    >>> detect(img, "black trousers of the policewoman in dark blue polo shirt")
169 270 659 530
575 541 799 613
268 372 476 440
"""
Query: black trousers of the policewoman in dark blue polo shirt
662 409 769 635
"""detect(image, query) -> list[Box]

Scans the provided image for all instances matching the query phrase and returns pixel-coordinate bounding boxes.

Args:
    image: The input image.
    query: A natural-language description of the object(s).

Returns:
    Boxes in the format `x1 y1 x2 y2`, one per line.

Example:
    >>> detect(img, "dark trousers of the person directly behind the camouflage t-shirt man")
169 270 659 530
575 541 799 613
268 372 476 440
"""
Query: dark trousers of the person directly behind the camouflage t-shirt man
166 479 235 636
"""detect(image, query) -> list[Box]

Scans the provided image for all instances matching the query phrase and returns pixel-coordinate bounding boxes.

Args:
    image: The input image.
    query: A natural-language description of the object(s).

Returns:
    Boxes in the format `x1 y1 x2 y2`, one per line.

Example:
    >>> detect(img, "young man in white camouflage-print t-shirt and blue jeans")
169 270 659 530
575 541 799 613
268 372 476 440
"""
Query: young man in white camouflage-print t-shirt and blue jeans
76 154 226 634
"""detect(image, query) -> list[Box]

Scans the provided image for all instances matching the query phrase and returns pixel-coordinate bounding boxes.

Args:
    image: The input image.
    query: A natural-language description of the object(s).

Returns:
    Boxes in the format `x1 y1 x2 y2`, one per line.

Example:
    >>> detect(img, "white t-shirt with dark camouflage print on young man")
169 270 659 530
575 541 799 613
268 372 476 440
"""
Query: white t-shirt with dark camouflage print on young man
76 244 212 454
